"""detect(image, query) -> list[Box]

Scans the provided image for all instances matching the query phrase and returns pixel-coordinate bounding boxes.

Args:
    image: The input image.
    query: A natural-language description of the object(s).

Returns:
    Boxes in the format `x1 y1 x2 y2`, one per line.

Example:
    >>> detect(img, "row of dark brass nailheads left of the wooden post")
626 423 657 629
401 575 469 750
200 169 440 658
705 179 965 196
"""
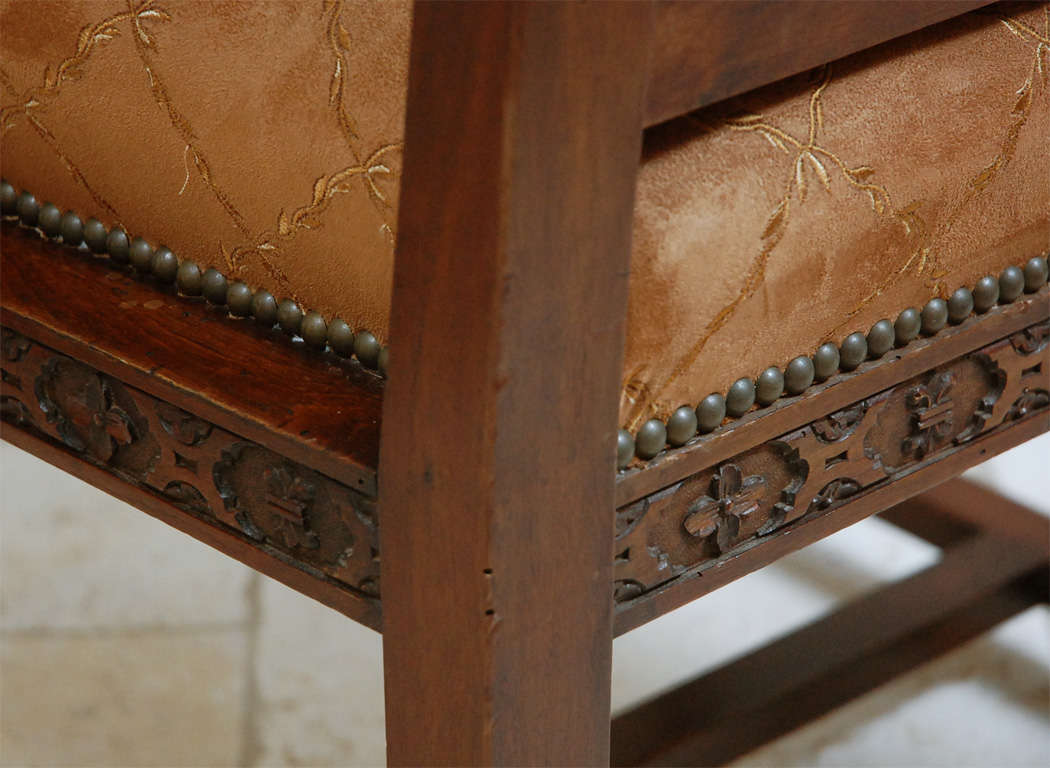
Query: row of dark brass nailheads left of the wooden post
0 180 390 378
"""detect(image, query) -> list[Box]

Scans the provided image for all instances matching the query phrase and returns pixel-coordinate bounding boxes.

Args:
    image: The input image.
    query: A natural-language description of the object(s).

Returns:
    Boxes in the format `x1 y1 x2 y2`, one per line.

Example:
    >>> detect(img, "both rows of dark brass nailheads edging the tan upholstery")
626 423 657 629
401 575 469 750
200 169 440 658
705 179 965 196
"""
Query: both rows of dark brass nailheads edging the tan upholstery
0 180 1050 470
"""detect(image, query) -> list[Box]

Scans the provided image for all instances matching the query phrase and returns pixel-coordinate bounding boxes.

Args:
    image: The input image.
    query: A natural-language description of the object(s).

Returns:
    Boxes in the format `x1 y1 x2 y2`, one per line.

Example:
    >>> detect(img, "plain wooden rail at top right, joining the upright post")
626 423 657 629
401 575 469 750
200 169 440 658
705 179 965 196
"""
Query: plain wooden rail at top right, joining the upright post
646 0 988 125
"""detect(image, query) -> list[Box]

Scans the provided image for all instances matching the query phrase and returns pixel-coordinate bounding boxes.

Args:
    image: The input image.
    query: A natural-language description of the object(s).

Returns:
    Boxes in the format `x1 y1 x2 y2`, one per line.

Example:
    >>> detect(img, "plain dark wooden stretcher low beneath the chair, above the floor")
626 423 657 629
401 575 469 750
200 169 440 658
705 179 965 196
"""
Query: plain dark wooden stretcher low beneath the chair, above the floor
612 480 1050 766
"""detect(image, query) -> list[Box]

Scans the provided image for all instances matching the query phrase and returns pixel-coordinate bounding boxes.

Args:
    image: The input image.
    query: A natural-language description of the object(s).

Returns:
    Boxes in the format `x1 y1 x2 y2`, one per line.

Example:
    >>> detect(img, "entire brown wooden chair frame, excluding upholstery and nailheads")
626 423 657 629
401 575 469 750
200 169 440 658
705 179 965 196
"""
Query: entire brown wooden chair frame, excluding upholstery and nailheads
2 2 1050 765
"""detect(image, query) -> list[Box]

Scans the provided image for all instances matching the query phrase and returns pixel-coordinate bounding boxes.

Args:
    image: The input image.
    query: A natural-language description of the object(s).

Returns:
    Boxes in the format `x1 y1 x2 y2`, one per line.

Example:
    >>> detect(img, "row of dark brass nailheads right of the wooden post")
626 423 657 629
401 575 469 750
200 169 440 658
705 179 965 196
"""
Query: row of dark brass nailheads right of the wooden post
616 254 1050 470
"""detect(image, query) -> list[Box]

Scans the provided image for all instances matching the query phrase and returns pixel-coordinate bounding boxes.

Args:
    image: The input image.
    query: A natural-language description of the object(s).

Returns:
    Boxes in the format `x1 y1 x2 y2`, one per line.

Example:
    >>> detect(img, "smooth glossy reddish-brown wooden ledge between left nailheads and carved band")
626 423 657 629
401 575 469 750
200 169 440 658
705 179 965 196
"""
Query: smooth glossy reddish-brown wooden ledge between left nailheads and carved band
0 222 382 496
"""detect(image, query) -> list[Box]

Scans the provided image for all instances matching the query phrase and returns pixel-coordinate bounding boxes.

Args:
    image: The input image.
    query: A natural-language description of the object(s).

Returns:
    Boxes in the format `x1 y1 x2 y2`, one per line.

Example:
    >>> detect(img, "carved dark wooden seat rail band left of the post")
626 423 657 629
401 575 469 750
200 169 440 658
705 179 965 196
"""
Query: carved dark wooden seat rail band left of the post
0 327 379 629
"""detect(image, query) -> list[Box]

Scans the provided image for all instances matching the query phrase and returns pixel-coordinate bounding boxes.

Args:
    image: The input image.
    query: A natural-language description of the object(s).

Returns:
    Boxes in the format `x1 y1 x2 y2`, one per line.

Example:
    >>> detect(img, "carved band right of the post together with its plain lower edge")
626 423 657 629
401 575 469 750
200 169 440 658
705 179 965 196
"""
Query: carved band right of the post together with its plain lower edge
615 320 1050 635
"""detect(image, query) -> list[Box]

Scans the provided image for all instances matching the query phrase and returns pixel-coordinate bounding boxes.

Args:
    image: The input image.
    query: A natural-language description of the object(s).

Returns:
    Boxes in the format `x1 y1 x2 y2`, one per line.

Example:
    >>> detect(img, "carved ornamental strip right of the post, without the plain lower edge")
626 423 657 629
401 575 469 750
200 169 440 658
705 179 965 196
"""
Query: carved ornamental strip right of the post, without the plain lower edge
613 323 1050 602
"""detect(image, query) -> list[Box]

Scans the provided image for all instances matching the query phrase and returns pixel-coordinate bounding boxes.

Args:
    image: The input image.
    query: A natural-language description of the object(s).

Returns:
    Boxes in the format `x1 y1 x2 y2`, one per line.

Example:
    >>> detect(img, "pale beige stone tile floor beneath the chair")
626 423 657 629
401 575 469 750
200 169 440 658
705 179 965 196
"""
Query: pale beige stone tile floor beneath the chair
0 437 1050 768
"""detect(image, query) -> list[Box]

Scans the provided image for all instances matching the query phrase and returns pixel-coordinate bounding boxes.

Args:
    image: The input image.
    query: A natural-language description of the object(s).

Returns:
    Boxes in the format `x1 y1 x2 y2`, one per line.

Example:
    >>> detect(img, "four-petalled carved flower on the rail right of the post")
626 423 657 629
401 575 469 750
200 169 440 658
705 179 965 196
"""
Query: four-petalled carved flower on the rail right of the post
683 462 765 552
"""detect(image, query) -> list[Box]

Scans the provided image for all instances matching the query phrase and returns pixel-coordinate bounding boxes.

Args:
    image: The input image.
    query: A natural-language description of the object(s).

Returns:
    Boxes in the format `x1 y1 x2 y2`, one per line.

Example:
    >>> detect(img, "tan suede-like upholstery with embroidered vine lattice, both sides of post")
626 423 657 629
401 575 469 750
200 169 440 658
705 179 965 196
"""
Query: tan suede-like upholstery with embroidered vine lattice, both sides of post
0 0 1050 427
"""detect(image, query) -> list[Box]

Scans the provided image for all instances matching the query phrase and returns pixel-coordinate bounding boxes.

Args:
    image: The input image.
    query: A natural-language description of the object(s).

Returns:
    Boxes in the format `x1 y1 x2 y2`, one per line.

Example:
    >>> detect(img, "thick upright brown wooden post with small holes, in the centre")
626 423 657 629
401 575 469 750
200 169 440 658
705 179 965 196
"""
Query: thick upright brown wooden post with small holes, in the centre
380 2 650 765
